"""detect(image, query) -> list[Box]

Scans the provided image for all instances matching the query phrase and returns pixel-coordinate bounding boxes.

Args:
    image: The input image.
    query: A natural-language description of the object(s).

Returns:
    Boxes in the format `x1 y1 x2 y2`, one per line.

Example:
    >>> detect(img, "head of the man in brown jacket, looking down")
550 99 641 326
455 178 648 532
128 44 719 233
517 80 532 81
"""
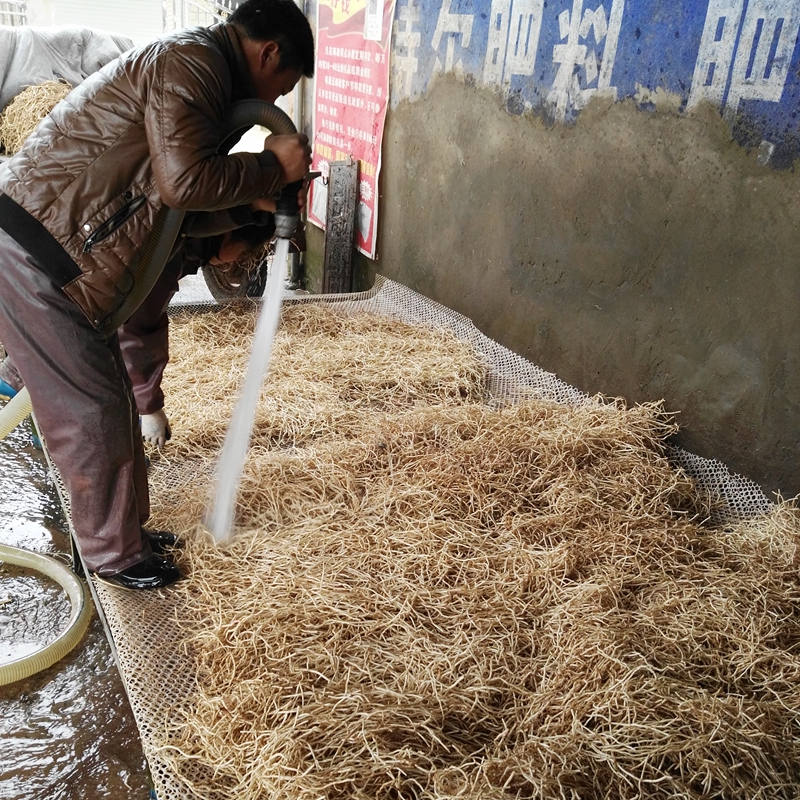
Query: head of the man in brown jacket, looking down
228 0 314 103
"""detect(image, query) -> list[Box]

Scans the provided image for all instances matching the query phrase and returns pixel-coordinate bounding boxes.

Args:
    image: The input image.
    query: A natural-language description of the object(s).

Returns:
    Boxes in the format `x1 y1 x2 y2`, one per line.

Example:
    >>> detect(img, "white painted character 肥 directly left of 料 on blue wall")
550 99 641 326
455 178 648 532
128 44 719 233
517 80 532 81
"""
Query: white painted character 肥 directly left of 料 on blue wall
483 0 544 86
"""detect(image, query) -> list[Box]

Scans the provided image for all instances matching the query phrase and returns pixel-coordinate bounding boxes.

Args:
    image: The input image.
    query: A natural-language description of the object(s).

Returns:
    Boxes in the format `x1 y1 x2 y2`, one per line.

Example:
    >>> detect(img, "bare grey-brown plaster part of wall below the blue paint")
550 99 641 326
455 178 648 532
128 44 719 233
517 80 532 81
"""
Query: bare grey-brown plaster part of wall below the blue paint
368 77 800 496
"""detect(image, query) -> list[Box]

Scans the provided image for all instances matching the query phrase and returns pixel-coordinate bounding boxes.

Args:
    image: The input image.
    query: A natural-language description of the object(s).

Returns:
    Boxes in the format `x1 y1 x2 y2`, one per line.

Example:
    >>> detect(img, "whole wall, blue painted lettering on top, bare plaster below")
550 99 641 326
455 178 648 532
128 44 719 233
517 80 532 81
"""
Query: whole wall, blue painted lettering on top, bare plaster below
308 0 800 495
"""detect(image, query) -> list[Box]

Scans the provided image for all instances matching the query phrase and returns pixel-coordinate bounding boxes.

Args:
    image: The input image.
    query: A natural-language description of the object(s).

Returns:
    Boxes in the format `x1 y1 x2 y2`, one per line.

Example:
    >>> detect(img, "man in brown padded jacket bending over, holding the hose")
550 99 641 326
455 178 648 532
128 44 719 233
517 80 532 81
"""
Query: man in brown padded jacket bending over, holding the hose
0 0 314 589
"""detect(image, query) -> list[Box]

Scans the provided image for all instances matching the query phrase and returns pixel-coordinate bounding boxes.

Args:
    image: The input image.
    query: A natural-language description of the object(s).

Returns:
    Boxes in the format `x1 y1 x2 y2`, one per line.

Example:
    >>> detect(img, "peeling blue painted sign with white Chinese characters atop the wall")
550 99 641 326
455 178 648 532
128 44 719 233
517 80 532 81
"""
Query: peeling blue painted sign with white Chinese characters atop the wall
392 0 800 167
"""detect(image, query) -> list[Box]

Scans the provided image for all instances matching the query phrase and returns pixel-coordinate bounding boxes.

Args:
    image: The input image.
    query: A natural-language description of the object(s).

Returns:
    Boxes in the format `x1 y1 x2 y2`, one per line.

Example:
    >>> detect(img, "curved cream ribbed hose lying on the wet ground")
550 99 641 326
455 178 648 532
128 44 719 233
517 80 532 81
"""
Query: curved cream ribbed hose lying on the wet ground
0 544 92 686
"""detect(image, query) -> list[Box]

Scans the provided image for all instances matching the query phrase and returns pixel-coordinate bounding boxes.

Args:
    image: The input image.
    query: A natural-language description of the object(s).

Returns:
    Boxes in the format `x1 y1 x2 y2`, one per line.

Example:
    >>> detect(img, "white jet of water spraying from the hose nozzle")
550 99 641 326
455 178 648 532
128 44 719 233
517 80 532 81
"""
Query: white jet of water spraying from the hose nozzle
206 234 289 544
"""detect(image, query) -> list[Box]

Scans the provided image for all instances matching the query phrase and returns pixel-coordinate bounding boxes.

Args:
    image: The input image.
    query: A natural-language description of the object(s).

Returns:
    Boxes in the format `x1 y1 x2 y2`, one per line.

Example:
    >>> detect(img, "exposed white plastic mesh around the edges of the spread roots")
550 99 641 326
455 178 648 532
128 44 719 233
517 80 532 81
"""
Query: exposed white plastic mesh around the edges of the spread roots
47 276 772 800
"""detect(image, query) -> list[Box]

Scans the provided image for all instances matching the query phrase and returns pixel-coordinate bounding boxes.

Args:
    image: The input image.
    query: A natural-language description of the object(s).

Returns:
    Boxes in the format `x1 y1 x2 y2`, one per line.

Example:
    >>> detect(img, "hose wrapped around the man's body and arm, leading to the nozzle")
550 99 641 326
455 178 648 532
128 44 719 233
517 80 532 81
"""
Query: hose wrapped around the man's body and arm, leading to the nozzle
0 100 297 439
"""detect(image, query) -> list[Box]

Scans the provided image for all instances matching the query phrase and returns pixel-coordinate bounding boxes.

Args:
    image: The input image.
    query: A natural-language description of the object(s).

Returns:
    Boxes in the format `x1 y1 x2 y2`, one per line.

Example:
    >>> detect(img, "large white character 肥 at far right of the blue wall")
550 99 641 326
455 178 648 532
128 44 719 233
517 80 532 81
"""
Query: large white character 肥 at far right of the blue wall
687 0 800 121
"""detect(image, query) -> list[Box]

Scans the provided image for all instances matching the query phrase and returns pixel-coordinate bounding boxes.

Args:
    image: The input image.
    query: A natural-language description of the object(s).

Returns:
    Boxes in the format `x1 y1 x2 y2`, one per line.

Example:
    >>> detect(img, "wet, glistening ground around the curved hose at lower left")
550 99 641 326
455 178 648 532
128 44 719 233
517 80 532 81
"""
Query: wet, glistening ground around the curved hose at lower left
0 412 149 800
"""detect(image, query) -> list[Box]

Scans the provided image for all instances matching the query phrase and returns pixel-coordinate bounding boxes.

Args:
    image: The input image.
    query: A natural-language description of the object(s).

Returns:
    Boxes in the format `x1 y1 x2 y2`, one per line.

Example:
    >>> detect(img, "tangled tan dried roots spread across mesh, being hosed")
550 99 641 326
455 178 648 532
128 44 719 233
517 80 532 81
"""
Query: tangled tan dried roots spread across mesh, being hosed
154 304 800 800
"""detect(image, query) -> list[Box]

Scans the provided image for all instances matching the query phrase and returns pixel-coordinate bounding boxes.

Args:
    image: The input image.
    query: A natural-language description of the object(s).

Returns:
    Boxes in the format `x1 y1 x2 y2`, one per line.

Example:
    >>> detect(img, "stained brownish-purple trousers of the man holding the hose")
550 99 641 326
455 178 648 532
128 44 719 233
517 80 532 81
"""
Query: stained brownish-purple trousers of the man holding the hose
0 230 151 575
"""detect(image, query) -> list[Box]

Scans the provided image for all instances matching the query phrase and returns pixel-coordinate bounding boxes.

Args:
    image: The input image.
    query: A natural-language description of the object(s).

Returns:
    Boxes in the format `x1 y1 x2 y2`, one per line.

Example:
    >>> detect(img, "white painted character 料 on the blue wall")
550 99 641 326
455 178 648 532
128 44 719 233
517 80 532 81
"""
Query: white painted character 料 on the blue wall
547 0 625 122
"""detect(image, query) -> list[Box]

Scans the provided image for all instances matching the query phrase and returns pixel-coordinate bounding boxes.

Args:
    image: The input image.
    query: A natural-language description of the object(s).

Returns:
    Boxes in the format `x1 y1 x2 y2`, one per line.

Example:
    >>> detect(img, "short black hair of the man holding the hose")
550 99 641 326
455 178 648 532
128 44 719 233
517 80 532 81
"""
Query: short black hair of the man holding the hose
227 0 314 78
